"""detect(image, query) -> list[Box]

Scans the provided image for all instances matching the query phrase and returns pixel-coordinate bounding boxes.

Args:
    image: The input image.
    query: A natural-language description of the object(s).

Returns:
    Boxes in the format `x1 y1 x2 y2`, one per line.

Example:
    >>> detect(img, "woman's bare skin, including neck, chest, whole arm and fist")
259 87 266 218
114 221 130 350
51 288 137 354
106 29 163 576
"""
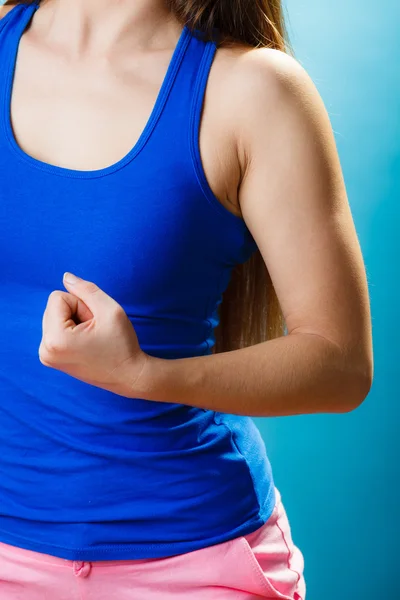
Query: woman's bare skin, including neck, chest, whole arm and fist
1 0 373 416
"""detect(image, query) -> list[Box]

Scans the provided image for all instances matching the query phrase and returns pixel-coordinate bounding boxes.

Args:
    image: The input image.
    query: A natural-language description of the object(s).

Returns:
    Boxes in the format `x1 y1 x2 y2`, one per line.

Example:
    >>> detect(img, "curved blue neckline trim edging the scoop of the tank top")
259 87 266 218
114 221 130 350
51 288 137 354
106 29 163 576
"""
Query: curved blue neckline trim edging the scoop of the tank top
1 2 191 179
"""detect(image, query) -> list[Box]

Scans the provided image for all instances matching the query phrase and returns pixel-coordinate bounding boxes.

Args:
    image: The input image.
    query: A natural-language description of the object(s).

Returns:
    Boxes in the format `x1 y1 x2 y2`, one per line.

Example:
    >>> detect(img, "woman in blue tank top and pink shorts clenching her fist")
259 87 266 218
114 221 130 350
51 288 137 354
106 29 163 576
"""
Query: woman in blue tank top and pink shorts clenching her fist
0 0 373 600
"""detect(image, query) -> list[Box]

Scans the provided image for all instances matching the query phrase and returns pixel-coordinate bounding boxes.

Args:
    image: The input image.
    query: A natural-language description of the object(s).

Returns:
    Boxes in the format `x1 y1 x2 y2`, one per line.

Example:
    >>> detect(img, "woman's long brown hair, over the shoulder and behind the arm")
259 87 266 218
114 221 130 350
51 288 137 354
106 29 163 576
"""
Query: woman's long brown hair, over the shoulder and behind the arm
5 0 293 353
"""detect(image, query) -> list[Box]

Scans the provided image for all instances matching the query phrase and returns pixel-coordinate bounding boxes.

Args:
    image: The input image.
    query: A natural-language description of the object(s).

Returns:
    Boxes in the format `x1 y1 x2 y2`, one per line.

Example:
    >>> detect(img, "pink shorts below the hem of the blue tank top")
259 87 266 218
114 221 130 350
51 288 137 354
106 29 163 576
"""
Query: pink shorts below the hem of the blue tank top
0 490 306 600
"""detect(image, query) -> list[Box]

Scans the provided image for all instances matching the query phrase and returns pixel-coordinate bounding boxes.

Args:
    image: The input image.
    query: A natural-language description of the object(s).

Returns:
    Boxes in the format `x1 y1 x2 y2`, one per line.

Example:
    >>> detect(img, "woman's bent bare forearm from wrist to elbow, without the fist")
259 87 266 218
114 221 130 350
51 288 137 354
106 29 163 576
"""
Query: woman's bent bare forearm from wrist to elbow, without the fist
127 333 369 417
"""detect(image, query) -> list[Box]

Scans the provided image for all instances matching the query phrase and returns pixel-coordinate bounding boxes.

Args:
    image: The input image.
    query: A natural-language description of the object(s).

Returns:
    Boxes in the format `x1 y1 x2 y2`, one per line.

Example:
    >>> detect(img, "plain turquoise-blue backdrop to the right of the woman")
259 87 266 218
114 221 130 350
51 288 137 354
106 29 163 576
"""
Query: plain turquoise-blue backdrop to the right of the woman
254 0 400 600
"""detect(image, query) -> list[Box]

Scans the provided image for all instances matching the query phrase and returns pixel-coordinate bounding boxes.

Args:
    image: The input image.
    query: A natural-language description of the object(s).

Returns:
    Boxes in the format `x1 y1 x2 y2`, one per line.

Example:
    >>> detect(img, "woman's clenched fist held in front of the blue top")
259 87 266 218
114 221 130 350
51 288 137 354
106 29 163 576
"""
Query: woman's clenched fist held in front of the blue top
39 273 150 396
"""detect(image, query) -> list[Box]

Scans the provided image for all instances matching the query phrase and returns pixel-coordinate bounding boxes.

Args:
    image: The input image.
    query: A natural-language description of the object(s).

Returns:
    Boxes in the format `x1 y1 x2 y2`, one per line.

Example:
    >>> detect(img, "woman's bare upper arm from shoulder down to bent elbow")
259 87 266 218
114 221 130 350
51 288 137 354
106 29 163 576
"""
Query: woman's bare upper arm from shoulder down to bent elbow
236 49 373 376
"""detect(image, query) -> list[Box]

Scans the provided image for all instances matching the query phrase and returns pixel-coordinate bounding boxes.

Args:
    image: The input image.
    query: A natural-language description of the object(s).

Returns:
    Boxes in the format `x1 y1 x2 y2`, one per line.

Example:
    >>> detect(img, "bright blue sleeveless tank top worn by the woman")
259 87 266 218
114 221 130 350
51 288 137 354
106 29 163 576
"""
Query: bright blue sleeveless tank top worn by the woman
0 4 275 561
